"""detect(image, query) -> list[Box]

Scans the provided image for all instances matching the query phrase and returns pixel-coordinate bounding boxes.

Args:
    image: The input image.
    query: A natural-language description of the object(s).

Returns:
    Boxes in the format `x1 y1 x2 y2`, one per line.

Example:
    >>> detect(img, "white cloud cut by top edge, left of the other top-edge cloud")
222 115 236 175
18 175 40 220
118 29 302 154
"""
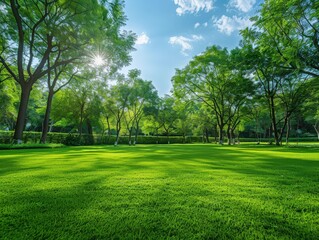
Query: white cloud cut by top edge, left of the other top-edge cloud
174 0 213 16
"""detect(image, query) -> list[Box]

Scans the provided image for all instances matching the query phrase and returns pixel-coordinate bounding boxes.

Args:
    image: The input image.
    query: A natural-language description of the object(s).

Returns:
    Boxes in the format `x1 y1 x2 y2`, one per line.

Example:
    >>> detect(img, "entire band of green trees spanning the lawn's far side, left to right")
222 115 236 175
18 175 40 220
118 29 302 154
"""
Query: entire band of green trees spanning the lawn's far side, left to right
0 0 319 145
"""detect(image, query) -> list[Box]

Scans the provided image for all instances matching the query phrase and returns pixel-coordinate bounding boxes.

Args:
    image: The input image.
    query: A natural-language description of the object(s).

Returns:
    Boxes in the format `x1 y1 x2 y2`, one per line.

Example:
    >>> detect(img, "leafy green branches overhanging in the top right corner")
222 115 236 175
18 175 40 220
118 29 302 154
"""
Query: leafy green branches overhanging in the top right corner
253 0 319 77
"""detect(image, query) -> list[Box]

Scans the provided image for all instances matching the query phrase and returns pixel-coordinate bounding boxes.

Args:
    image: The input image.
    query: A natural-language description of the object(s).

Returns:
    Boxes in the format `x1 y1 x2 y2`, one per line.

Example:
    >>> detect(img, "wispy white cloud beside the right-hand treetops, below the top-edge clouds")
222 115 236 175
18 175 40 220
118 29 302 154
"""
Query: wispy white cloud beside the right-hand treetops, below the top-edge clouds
214 15 252 35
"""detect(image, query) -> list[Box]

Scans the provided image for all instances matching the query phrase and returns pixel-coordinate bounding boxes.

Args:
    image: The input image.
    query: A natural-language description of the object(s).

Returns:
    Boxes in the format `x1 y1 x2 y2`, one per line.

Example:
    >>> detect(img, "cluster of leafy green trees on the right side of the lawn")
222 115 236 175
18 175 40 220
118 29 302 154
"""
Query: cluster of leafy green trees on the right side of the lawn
173 0 319 145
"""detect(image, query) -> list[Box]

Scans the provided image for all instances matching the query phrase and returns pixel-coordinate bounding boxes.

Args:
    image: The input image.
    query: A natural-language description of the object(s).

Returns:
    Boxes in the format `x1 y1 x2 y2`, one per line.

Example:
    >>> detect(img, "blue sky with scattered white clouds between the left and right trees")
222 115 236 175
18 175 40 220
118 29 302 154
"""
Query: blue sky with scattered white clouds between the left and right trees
123 0 262 96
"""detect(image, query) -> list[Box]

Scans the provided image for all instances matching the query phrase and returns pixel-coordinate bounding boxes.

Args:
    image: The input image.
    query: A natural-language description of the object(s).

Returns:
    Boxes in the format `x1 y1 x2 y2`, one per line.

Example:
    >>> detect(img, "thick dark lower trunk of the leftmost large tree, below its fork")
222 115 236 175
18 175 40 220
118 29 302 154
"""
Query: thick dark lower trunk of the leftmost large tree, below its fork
13 85 31 144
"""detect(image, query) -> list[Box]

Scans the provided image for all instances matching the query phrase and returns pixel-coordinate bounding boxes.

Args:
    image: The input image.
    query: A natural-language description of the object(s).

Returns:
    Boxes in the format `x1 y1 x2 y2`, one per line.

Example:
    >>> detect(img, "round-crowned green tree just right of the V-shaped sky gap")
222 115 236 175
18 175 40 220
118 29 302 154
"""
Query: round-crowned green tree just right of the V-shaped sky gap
172 46 252 144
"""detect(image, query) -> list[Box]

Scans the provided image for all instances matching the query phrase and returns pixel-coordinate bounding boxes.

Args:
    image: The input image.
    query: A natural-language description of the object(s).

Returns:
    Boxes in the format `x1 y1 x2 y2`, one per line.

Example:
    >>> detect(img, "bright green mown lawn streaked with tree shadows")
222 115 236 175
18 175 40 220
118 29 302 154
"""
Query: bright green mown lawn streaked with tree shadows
0 145 319 240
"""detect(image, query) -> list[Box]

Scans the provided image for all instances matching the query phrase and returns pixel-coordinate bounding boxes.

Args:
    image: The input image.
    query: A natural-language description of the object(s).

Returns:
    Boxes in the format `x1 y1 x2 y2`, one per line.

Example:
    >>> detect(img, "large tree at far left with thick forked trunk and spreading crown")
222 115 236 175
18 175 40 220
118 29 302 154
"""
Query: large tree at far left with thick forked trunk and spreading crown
0 0 133 142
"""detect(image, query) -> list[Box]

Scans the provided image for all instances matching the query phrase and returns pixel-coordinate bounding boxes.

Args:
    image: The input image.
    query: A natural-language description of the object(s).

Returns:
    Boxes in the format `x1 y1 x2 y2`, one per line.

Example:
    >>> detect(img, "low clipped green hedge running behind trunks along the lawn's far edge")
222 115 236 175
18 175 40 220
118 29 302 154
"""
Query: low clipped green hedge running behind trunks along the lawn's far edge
0 131 318 146
